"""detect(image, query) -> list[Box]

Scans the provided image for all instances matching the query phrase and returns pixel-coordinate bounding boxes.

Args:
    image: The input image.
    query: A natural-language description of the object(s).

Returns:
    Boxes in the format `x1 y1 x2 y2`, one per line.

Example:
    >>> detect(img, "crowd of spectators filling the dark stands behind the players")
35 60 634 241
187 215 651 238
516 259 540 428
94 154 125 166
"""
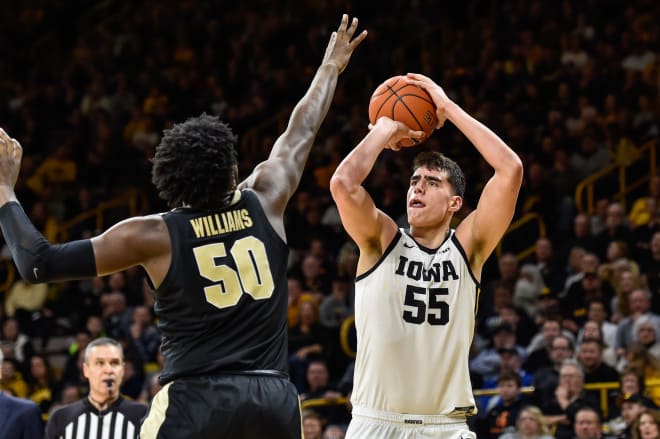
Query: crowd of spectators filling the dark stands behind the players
0 0 660 439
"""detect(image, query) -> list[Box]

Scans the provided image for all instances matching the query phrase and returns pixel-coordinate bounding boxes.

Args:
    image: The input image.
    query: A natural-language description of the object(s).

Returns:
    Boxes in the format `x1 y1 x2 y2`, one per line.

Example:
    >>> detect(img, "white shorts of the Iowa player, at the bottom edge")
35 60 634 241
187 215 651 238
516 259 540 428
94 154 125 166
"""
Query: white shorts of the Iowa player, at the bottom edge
346 407 477 439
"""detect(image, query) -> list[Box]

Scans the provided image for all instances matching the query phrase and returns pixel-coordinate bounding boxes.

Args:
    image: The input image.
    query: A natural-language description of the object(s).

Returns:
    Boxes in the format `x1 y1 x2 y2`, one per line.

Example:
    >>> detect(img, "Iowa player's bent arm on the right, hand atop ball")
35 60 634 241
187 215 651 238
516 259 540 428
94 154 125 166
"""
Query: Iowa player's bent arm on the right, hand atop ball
408 73 523 271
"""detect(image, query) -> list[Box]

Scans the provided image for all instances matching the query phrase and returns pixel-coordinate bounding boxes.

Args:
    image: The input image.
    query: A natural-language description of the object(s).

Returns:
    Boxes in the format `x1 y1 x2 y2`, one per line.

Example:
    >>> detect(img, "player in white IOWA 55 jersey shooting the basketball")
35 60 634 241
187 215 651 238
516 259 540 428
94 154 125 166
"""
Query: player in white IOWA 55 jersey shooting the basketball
330 74 523 439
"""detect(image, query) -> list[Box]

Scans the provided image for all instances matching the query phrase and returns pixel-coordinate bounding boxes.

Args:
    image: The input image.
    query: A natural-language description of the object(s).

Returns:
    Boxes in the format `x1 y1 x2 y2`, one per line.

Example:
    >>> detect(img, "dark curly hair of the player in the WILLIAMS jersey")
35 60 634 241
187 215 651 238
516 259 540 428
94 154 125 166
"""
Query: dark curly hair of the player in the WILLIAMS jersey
151 113 238 208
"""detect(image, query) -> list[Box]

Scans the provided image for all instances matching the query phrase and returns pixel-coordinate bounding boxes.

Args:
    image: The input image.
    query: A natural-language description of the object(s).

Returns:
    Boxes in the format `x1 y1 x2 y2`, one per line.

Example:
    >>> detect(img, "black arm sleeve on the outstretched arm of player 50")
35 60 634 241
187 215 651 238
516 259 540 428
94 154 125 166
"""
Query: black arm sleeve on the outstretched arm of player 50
0 201 97 283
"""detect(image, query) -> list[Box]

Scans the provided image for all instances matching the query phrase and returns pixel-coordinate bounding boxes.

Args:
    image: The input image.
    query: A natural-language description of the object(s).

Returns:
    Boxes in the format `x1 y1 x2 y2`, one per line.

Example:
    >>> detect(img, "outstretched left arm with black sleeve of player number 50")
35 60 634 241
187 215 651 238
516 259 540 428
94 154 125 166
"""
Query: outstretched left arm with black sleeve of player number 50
0 128 169 283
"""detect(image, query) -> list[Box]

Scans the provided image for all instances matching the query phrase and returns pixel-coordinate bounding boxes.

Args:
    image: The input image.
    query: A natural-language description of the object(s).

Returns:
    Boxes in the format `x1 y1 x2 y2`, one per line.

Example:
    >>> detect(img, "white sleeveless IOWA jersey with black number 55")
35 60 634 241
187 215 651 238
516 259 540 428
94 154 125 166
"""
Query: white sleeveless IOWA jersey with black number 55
351 230 479 415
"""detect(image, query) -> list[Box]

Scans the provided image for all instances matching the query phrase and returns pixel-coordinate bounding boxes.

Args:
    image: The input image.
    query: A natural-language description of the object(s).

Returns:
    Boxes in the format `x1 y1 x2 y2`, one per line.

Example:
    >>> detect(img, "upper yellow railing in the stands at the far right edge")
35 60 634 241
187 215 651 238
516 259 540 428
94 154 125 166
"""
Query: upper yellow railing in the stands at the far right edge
575 140 657 214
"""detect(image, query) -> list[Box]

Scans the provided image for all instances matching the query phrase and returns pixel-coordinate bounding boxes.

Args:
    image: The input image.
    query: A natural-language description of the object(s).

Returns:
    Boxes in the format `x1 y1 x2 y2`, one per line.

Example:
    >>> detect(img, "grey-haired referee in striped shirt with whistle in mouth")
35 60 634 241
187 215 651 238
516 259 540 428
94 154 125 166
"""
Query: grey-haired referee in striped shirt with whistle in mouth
45 338 147 439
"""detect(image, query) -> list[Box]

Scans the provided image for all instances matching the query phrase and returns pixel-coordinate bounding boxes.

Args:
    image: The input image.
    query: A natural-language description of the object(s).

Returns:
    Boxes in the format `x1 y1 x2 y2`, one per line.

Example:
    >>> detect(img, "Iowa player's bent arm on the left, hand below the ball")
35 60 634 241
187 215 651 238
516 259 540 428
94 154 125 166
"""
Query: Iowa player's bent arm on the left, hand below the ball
330 117 424 272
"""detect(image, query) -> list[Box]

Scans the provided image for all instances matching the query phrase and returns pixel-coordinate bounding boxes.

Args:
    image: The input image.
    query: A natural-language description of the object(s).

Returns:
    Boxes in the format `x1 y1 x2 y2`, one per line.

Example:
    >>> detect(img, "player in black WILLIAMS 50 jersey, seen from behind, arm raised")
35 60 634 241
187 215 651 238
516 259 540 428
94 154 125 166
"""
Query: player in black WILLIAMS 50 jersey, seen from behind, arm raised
0 15 366 439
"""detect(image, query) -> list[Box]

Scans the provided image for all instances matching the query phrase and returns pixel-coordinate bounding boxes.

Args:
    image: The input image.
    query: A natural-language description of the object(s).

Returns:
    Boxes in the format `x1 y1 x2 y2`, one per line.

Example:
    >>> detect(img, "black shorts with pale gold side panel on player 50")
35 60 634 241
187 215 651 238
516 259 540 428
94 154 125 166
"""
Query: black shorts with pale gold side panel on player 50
140 375 302 439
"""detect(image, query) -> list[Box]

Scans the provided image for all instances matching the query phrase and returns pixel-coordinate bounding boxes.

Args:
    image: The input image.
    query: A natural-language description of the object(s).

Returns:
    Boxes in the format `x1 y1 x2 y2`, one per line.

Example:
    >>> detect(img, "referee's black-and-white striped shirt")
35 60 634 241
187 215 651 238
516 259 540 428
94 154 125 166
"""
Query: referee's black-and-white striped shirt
46 397 147 439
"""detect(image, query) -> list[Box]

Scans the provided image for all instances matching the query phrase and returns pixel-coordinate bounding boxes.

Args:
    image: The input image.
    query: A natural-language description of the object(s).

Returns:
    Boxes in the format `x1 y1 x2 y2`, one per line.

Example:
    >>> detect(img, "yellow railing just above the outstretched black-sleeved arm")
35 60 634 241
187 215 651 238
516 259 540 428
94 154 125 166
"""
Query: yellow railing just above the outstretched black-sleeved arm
57 189 149 242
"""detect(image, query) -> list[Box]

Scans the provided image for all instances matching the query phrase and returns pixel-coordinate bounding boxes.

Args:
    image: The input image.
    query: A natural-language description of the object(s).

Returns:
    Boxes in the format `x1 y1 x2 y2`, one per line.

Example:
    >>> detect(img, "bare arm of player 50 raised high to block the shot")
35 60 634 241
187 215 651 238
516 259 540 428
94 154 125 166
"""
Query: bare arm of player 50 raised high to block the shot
239 15 367 218
